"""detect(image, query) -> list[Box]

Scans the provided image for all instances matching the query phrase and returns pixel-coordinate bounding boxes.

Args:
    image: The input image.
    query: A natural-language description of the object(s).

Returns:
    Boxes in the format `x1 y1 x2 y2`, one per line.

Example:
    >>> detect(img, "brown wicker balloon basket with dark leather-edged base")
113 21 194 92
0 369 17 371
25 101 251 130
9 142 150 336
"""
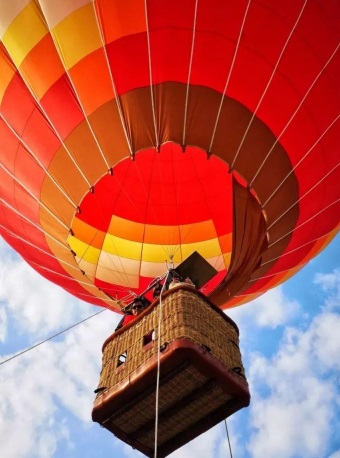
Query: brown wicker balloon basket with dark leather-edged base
92 285 250 457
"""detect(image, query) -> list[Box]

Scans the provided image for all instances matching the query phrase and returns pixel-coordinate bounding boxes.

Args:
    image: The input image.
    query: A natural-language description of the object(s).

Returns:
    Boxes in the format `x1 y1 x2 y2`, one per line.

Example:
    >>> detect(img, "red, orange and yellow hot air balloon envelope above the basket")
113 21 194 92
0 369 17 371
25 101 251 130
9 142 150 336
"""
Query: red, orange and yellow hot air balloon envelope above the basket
0 0 340 456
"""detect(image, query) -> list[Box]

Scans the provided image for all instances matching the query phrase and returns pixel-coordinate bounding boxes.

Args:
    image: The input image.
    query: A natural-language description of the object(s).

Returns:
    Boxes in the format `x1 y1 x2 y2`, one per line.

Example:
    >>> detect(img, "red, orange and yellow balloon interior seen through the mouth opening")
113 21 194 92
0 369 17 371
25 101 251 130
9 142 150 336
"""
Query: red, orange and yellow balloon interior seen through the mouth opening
68 143 240 299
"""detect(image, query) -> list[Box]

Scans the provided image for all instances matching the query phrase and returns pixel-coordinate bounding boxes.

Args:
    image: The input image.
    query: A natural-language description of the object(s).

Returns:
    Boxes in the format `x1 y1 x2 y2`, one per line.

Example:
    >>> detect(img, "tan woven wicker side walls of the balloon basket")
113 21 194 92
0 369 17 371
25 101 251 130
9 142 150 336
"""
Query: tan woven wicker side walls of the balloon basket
95 289 247 396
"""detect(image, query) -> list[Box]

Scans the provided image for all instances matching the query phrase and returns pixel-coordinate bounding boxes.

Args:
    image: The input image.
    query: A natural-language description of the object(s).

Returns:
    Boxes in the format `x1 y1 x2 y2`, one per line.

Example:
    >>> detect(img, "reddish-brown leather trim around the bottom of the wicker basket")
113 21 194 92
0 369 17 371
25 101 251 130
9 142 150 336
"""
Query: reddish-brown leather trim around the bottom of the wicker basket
92 339 250 458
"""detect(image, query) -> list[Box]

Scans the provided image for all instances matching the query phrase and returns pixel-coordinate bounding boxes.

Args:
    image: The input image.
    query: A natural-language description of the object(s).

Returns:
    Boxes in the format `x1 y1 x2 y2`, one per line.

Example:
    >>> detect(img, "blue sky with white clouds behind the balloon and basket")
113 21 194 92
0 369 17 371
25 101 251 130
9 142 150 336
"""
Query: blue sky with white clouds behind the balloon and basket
0 236 340 458
